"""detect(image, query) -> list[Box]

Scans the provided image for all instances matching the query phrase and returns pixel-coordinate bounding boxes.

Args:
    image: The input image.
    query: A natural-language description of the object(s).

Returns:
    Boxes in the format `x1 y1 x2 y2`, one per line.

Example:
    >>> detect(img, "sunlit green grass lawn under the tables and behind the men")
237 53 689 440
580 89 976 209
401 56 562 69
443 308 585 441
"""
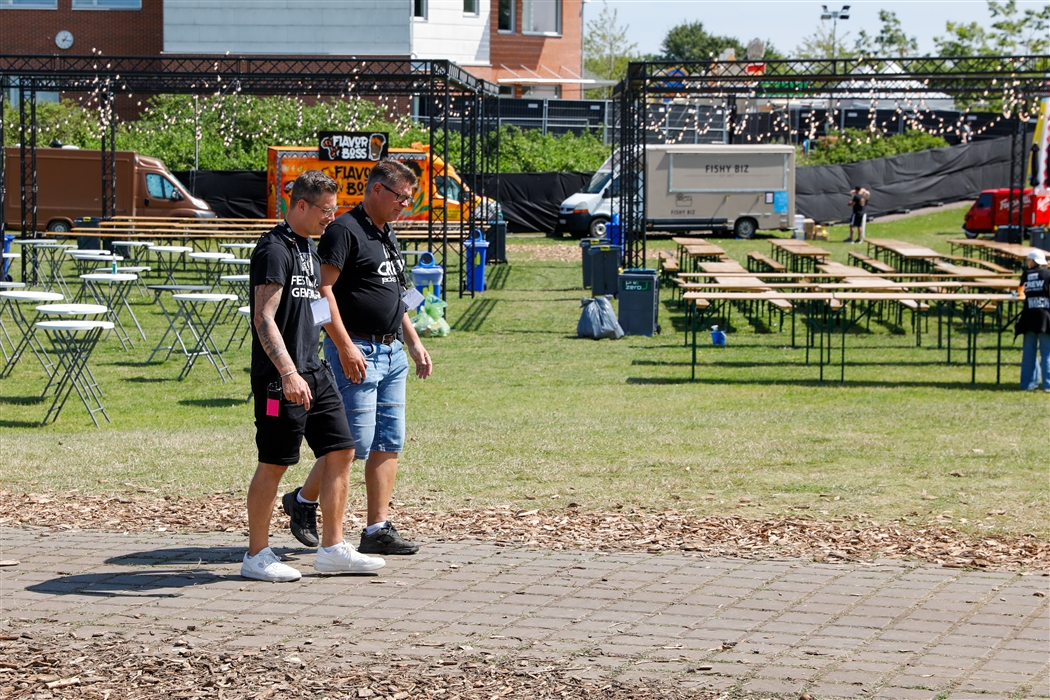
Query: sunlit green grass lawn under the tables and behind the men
0 209 1050 539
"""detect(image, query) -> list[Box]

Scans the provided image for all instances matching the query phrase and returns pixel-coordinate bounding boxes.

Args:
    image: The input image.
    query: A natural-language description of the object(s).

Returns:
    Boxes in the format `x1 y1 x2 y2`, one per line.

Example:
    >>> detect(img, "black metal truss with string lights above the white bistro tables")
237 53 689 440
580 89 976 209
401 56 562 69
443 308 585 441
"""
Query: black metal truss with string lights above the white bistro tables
0 55 499 296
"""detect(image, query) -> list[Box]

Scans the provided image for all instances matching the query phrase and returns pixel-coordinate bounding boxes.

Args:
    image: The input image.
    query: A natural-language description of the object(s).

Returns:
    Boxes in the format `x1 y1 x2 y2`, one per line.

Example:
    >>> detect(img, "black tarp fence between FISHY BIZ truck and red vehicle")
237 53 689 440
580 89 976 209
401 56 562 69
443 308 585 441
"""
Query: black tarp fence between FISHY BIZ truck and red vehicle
795 139 1010 224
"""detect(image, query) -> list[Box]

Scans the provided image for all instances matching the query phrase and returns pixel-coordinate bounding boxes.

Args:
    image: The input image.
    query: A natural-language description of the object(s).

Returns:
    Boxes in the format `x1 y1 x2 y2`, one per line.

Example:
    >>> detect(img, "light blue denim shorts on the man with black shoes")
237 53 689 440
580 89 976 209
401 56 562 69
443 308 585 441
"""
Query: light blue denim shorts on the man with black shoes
324 338 408 460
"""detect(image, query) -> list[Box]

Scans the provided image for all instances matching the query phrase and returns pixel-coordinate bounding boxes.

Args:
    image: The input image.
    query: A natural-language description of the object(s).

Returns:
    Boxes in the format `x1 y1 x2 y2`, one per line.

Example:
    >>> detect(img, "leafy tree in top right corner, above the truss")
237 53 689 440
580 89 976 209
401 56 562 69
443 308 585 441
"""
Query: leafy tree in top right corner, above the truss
933 0 1050 56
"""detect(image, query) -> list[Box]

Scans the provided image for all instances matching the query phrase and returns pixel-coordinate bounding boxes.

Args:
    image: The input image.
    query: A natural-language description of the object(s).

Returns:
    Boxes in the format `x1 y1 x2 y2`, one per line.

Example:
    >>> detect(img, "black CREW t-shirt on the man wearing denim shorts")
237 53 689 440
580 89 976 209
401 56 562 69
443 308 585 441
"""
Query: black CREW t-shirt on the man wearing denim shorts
318 205 406 336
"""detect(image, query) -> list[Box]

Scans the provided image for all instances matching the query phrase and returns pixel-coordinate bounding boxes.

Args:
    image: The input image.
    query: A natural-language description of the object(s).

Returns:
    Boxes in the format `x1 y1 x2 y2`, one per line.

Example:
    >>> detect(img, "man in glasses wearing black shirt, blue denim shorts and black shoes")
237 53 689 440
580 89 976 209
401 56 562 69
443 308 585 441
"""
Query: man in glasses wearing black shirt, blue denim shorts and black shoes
281 160 433 554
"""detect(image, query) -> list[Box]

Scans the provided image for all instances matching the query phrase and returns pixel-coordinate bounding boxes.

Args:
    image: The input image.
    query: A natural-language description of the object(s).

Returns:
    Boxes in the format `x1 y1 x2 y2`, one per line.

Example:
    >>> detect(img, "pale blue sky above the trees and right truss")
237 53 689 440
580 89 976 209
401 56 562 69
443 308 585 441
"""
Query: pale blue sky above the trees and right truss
596 0 1046 54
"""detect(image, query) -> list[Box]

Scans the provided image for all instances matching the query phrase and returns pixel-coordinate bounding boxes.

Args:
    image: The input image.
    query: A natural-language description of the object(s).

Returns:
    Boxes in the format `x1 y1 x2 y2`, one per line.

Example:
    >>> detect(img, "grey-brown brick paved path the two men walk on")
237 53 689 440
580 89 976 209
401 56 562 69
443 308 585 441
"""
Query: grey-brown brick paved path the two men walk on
0 527 1050 700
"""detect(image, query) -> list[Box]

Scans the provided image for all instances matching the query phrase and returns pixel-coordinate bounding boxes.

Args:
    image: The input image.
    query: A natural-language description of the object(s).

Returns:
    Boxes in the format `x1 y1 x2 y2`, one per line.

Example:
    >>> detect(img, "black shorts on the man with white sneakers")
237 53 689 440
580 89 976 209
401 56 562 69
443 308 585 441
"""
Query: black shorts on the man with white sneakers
252 366 354 466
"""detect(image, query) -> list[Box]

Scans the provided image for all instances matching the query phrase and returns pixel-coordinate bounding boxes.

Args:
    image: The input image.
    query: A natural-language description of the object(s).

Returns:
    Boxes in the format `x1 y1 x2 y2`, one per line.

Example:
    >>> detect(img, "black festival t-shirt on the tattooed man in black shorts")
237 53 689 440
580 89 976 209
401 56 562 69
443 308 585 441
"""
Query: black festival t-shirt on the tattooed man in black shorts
250 221 321 379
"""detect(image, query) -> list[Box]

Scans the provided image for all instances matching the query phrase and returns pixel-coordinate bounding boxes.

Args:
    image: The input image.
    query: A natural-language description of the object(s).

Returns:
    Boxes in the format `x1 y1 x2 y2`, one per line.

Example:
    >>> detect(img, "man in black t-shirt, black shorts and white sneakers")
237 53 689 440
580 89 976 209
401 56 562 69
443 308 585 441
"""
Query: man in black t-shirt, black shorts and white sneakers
240 170 385 581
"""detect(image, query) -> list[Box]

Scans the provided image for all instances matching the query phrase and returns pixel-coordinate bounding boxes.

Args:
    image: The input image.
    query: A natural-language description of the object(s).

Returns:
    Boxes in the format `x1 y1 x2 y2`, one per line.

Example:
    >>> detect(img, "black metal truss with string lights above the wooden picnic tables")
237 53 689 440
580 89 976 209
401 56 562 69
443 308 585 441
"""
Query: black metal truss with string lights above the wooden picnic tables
614 56 1050 268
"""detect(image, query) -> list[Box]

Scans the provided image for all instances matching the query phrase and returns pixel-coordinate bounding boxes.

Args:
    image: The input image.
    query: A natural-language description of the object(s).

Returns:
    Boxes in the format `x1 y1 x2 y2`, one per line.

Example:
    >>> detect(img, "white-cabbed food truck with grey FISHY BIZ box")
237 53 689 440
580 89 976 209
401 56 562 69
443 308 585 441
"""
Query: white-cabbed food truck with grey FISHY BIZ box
555 144 795 238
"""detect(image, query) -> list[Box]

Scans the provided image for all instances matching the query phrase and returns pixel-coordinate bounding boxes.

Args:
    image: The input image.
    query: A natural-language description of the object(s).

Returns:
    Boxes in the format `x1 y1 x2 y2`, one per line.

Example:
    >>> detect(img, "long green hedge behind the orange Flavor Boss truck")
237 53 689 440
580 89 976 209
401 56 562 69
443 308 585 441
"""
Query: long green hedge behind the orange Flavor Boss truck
4 94 610 172
